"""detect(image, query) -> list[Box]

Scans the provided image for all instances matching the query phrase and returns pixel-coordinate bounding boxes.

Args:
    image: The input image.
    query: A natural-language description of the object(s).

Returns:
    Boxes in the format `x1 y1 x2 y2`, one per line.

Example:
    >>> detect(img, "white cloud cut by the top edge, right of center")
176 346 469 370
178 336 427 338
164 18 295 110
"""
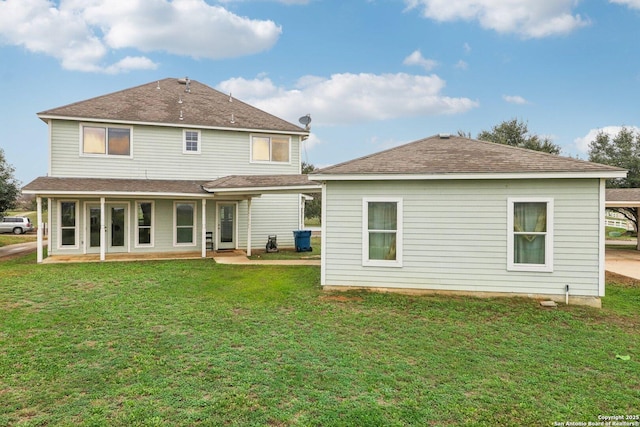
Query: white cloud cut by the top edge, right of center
405 0 592 38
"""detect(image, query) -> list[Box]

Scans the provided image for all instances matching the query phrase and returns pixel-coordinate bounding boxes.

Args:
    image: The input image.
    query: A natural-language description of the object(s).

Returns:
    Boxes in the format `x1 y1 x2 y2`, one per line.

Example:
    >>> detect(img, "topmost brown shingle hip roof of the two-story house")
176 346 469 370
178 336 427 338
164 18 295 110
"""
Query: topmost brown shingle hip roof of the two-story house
38 78 308 134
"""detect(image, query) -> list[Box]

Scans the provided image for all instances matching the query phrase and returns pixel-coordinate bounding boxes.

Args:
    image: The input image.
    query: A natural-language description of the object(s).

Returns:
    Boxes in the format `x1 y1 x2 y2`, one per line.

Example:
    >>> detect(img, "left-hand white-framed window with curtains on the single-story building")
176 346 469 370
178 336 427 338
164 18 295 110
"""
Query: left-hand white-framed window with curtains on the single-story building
362 198 402 267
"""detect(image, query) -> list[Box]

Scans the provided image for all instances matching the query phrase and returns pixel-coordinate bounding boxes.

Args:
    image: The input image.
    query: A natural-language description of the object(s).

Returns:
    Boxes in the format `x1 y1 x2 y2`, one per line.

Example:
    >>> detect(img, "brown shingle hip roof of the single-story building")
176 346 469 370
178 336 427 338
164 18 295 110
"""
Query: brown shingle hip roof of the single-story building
313 135 624 177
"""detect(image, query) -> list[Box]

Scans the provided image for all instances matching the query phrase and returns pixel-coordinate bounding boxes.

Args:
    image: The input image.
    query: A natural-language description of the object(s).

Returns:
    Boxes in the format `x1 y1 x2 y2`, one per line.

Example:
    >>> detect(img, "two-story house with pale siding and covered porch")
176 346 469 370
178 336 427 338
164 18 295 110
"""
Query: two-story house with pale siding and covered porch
23 78 319 262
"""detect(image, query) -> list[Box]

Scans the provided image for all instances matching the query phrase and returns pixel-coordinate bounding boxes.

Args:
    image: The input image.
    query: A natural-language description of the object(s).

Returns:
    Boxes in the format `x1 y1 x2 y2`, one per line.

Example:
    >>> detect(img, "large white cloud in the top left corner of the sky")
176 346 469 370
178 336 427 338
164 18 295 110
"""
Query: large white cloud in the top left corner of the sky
0 0 282 73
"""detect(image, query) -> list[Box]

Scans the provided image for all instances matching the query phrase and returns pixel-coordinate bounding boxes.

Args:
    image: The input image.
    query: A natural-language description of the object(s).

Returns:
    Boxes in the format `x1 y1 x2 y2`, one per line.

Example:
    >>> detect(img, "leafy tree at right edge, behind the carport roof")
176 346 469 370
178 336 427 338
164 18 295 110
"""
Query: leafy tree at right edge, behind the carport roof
589 127 640 250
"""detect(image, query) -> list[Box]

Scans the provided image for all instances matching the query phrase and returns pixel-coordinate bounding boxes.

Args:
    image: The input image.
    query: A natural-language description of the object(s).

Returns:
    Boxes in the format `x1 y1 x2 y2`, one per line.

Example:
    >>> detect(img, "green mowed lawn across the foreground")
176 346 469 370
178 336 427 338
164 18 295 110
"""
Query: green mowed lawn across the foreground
0 255 640 426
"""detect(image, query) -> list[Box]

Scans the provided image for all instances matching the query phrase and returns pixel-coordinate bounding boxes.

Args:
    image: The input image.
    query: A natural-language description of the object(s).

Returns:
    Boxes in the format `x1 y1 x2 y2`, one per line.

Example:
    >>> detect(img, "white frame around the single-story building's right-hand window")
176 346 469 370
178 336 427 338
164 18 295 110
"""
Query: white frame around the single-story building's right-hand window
507 197 554 273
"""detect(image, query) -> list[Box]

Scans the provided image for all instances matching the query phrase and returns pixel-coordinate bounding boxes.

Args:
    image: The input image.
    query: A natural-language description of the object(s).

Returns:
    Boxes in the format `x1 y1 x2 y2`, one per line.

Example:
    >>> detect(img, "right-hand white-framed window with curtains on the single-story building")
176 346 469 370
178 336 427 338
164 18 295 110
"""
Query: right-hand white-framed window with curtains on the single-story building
507 198 553 272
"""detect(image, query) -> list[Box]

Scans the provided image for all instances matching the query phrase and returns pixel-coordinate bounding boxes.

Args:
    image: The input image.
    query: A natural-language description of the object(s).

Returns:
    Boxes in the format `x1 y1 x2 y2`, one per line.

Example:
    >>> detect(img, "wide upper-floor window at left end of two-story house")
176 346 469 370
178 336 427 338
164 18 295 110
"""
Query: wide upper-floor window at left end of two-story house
82 126 131 156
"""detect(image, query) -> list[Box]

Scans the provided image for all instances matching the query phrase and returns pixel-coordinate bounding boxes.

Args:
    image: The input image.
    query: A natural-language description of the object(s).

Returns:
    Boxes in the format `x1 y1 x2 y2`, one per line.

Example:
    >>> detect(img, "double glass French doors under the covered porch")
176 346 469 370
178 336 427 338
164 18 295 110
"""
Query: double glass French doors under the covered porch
87 204 128 253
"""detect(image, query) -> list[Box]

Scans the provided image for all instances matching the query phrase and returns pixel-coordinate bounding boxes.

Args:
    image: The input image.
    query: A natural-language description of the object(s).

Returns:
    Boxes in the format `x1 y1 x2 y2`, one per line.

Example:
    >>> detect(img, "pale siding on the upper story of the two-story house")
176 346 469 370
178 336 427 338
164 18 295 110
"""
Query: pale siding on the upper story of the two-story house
51 120 300 180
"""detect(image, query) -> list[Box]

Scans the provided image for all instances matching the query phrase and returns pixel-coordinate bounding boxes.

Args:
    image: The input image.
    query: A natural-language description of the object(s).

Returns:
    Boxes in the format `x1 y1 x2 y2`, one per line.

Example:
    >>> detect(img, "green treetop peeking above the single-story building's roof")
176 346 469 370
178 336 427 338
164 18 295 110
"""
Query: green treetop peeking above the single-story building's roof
478 119 560 154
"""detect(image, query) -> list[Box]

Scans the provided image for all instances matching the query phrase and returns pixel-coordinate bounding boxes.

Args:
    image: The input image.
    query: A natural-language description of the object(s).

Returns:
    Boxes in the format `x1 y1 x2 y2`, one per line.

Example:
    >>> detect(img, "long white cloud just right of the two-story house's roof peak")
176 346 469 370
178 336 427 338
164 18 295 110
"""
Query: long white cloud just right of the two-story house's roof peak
218 73 478 127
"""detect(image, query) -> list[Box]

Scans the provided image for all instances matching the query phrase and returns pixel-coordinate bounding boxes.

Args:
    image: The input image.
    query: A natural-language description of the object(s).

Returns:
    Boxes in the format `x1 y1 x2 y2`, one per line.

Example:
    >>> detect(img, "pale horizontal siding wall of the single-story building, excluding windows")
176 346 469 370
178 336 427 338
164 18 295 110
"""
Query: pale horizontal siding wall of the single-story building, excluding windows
323 179 600 297
